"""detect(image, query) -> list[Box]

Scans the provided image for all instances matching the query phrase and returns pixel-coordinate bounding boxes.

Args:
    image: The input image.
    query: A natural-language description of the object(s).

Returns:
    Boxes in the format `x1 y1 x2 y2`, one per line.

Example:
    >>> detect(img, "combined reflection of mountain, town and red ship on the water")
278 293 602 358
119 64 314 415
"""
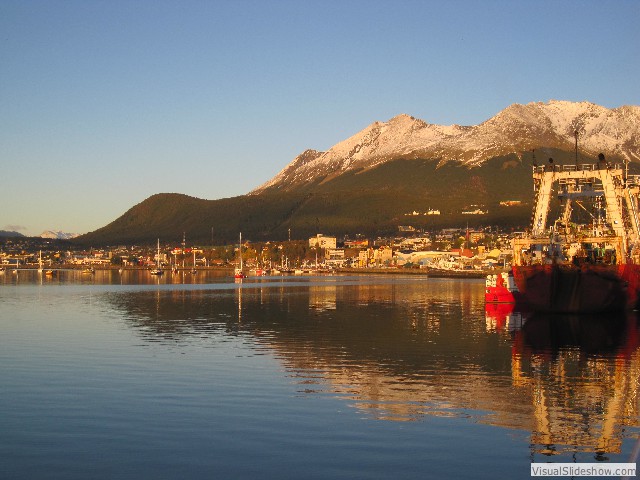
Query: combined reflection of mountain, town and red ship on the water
100 277 640 461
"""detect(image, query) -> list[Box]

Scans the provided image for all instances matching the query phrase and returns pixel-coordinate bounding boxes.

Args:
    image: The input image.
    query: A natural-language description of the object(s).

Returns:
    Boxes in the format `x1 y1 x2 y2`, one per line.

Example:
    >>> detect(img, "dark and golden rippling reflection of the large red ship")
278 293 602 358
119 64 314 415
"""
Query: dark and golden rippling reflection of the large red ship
487 305 640 460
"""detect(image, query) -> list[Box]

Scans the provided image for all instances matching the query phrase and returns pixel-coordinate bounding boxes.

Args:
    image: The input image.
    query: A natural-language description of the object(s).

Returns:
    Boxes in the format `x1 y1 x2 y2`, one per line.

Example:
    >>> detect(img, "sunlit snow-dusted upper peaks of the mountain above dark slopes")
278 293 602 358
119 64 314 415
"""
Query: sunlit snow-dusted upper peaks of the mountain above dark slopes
251 100 640 194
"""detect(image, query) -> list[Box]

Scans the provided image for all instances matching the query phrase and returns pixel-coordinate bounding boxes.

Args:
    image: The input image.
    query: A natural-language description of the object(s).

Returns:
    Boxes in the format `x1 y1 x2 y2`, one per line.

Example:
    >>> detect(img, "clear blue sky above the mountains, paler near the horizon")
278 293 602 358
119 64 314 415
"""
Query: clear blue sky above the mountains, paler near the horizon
0 0 640 235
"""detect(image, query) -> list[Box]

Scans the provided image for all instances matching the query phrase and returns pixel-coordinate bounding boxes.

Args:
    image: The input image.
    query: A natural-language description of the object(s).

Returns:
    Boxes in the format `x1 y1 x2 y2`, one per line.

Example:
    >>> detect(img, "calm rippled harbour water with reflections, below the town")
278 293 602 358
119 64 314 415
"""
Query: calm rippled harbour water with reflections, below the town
0 272 640 479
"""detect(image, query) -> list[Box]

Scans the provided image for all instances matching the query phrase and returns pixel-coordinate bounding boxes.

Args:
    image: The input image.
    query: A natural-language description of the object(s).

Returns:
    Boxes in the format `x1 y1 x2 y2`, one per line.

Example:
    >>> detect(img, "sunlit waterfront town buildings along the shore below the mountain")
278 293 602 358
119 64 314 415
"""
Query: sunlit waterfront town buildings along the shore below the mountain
0 227 513 275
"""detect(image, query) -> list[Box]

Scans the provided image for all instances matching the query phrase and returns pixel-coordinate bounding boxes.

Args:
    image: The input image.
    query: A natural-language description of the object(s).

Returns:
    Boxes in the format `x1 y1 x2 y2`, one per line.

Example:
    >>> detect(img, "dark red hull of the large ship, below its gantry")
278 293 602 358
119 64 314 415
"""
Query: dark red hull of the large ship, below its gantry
513 265 640 313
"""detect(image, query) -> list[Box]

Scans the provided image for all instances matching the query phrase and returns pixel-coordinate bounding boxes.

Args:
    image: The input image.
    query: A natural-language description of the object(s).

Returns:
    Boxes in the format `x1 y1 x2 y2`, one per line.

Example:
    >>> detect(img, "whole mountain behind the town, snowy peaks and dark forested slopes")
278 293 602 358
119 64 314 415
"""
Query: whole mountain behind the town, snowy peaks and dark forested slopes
77 101 640 244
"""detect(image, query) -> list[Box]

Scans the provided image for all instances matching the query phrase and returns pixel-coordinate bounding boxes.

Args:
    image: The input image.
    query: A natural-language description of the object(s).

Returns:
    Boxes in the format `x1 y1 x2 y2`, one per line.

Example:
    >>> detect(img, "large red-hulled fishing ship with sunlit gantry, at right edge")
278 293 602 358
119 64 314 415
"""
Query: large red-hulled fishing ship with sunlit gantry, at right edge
512 152 640 313
